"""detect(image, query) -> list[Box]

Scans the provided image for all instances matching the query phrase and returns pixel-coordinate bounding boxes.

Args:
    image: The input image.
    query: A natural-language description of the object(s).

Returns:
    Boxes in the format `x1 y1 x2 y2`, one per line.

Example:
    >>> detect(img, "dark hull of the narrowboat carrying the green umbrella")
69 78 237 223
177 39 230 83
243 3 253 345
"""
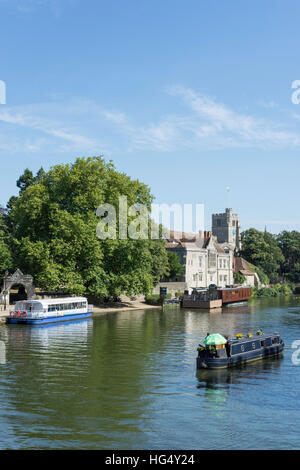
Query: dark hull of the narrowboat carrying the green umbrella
197 343 284 369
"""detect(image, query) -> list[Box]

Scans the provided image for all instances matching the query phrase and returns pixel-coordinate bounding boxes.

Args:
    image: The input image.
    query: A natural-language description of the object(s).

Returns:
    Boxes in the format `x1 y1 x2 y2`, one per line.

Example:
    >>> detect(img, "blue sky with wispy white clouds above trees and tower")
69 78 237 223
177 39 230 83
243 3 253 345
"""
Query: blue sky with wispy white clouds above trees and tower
0 0 300 233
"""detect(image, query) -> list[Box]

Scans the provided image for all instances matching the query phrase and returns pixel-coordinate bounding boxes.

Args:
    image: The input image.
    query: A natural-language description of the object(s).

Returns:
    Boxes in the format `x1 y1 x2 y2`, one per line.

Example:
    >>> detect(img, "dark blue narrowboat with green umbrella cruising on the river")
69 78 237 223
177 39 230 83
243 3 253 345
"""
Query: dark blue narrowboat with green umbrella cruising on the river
197 330 284 369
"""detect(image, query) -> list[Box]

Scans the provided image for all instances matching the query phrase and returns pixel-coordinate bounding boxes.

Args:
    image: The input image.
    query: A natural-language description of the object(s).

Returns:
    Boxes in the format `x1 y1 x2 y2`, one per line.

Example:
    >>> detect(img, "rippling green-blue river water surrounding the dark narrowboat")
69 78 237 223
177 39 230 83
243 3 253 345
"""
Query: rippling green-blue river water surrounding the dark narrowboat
0 298 300 450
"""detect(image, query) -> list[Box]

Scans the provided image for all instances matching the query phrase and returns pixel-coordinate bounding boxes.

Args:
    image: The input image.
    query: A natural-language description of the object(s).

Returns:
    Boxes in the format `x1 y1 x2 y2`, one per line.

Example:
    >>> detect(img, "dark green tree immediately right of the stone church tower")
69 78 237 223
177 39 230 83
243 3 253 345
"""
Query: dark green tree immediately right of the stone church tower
241 228 284 280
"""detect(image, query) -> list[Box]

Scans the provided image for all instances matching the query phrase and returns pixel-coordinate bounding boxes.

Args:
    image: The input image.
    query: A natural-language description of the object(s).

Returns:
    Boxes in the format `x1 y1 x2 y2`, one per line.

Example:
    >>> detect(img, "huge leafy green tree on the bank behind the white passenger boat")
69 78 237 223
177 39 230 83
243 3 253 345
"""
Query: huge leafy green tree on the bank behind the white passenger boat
9 157 168 297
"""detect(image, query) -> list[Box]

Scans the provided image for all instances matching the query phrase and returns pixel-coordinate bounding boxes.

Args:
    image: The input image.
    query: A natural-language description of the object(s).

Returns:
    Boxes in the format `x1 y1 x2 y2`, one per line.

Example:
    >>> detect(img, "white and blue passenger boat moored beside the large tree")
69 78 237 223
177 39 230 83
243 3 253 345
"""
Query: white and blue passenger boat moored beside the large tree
6 297 93 325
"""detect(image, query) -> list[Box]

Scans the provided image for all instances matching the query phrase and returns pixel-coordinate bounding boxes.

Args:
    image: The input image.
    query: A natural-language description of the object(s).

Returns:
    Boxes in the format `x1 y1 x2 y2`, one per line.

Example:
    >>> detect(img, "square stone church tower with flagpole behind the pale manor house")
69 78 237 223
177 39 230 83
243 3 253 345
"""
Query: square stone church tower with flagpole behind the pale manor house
212 209 242 253
